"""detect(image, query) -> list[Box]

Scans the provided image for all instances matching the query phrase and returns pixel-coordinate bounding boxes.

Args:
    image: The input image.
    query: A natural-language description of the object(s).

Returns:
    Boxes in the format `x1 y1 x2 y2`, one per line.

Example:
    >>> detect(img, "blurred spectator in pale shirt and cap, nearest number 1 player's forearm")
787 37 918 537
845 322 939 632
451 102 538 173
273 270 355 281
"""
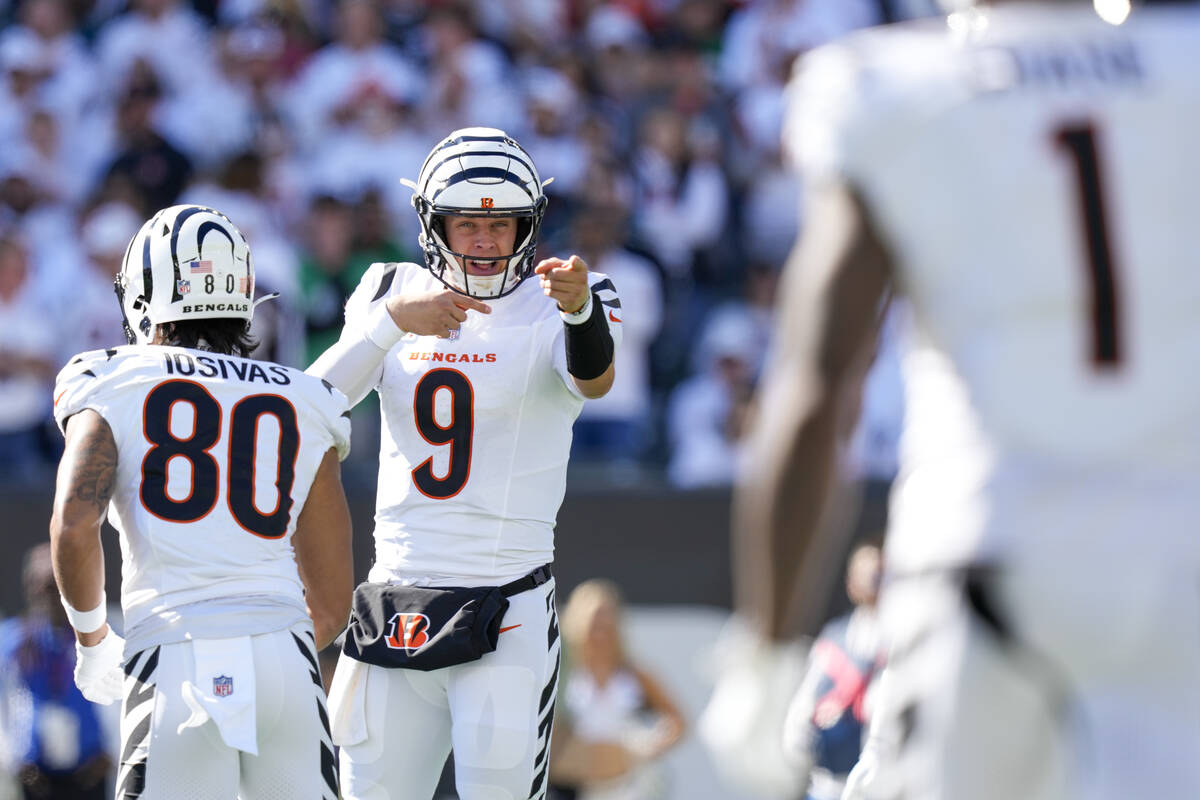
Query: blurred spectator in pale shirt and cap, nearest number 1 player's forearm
666 315 760 488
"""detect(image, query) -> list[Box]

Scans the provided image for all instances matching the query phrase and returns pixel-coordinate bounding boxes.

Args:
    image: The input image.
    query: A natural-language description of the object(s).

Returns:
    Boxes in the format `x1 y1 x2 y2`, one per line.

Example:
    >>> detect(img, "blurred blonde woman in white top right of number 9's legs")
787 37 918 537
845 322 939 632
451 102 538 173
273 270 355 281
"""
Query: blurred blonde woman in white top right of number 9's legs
550 578 684 800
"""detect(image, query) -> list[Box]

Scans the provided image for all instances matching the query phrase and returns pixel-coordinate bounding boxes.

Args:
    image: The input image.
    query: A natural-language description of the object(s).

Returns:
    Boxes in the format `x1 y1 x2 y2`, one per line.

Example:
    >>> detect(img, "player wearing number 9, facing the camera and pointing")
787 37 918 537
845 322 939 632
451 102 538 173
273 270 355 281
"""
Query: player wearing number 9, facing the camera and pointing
310 128 622 800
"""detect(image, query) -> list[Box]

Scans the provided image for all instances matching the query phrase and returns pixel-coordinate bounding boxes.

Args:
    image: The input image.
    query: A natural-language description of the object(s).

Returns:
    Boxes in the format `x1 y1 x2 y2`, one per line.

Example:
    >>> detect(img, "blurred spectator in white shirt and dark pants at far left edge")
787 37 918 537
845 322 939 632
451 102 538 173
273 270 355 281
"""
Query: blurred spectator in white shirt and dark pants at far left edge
0 235 59 481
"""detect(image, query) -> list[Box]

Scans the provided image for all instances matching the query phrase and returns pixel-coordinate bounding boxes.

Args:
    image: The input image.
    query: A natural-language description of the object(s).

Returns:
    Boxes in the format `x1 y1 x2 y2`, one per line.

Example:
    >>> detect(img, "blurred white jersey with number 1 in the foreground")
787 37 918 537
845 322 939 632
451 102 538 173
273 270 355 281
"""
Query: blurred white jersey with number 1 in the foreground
785 2 1200 570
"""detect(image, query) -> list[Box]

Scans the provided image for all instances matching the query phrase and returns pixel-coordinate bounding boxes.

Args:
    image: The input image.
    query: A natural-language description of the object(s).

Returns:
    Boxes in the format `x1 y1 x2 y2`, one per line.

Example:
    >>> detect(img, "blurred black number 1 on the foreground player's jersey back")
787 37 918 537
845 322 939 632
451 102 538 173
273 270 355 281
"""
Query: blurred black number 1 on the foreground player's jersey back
1055 125 1121 368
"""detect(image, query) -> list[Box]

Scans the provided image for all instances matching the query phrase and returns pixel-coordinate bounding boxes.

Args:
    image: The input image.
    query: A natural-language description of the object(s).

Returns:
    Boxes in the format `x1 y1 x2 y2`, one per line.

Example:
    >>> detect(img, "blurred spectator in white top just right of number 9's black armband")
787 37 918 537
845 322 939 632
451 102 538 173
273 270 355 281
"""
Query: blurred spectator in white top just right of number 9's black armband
571 204 662 470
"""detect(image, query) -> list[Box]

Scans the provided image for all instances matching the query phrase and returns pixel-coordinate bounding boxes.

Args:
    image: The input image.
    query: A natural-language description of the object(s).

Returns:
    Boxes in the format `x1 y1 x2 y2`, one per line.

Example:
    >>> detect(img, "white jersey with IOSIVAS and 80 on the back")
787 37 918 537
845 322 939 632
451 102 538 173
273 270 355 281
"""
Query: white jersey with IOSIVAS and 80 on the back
54 345 350 654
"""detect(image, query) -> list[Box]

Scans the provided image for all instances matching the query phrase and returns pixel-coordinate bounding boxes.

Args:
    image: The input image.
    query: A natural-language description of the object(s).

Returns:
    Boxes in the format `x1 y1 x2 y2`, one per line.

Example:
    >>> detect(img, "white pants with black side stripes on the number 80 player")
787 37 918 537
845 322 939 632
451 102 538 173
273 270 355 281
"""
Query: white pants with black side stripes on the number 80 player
116 625 337 800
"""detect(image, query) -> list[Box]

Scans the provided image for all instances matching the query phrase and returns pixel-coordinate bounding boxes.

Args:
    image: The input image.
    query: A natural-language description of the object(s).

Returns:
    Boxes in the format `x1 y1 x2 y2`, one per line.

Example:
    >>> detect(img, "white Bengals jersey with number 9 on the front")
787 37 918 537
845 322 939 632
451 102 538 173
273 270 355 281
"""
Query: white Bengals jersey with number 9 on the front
346 264 622 585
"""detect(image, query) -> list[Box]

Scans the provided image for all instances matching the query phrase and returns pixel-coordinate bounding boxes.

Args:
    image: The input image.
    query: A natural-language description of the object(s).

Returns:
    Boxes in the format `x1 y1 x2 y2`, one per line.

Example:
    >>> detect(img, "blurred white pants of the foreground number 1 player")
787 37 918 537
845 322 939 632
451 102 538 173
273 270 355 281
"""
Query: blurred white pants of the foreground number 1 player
871 530 1200 800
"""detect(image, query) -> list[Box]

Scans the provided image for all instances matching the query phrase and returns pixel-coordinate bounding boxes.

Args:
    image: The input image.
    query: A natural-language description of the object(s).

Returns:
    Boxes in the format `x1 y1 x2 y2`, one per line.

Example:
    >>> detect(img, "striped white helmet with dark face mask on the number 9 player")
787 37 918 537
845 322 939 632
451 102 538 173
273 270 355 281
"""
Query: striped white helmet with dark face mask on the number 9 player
403 127 550 299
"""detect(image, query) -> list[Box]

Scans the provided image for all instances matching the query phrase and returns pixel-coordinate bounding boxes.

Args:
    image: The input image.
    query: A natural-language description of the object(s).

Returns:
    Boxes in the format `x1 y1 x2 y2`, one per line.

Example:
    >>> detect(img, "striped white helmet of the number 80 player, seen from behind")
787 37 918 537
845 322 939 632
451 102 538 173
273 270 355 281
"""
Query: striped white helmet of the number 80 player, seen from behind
115 205 254 344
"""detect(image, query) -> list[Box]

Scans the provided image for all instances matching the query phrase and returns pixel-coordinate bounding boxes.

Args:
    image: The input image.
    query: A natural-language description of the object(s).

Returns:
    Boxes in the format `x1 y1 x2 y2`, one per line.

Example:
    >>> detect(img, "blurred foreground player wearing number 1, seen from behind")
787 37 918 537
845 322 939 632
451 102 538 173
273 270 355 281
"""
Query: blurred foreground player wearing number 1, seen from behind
705 1 1200 800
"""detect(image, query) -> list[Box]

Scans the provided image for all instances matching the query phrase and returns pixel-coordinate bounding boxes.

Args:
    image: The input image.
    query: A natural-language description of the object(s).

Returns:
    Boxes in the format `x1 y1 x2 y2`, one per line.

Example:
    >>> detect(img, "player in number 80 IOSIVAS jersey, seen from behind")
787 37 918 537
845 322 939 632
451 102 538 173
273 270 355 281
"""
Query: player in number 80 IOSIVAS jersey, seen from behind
50 205 354 800
